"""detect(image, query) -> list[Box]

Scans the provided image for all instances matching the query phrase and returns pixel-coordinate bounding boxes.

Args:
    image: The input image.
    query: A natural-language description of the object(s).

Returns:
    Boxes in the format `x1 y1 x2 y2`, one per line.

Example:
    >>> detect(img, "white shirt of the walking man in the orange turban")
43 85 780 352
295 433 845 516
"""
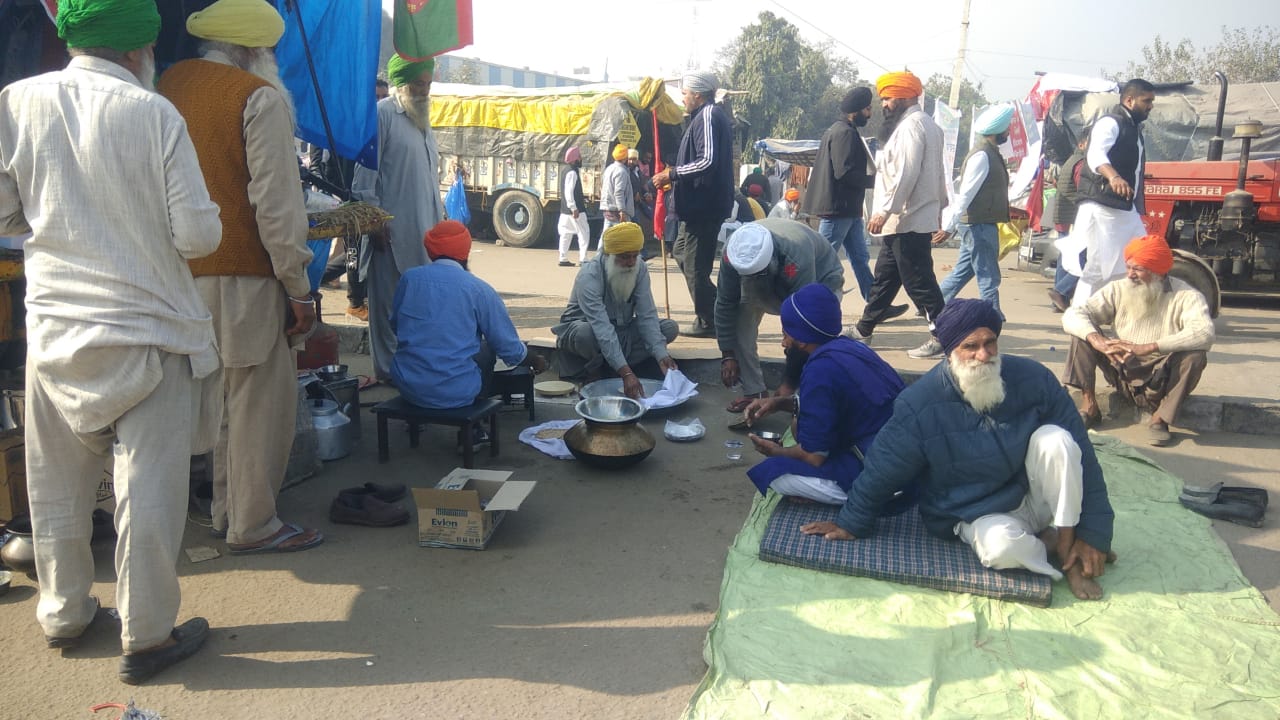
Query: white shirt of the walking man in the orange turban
872 105 950 236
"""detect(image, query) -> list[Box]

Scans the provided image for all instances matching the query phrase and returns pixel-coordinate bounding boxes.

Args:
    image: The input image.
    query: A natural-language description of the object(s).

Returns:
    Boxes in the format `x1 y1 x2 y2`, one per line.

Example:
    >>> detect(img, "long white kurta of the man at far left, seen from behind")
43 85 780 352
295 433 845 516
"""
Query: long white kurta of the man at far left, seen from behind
0 56 221 432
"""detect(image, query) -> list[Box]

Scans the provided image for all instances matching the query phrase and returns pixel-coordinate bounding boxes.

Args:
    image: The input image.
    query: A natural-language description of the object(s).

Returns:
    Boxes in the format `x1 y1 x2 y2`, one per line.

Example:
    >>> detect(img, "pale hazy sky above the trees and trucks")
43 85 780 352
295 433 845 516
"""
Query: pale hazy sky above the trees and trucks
384 0 1280 100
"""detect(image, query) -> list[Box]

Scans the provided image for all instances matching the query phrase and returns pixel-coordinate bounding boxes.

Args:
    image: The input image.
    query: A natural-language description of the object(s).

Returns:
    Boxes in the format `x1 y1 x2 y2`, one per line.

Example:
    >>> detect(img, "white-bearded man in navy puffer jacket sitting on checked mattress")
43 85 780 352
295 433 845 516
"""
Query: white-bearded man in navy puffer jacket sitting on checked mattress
801 300 1115 600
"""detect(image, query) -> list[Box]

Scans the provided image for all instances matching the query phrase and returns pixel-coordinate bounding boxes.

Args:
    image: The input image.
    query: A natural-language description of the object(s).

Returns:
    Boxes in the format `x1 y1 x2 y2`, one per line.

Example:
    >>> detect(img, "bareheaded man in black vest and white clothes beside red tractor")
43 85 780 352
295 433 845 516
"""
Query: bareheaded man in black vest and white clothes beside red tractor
1071 78 1156 299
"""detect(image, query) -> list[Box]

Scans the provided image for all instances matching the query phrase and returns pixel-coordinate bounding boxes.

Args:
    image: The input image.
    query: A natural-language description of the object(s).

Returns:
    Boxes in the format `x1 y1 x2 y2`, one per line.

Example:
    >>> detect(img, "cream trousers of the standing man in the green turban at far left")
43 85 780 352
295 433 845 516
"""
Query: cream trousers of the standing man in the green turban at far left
27 352 202 652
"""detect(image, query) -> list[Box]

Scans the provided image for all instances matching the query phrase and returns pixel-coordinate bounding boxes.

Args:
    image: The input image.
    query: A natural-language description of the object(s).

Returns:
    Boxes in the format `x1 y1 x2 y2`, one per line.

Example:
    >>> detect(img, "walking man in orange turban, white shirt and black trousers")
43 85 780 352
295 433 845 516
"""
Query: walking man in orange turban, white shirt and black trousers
847 72 948 357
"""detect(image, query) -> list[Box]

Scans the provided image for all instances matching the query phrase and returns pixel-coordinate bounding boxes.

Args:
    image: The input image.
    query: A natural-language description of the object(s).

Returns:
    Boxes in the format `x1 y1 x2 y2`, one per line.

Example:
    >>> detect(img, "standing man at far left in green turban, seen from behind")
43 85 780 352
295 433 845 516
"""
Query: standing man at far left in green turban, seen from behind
0 0 222 684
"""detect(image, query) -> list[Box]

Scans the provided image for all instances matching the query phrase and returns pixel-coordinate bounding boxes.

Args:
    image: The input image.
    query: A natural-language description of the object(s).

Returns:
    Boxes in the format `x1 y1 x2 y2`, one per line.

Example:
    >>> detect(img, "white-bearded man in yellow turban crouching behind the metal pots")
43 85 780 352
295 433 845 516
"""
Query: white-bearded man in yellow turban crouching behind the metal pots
552 223 678 398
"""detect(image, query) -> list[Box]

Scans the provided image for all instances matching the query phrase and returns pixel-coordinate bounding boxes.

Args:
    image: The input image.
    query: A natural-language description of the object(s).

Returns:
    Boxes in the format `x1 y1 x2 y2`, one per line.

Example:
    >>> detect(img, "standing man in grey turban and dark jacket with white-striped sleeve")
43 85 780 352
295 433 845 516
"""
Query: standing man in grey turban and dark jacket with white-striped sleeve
653 72 733 337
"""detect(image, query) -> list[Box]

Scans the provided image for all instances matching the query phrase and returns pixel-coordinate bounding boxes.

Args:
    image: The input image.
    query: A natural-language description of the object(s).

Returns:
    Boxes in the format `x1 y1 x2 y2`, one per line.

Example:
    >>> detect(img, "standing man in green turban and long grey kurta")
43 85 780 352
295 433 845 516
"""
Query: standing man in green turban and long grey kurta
351 55 445 382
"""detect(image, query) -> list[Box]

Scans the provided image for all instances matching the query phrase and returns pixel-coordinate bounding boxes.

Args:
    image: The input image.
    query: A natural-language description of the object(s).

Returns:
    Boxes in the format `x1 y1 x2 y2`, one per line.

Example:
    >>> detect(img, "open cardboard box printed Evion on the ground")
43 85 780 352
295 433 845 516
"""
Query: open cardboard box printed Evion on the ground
413 468 538 550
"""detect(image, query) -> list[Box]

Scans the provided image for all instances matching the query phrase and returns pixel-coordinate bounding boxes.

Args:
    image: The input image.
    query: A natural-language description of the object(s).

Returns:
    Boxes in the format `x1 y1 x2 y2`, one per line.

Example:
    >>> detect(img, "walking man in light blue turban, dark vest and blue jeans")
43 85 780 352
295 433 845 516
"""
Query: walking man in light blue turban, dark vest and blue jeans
933 105 1014 311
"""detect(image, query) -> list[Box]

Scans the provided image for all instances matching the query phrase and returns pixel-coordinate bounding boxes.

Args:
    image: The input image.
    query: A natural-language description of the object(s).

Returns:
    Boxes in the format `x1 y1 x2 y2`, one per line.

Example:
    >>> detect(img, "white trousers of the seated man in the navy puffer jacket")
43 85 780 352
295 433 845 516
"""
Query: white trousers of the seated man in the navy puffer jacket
955 425 1084 580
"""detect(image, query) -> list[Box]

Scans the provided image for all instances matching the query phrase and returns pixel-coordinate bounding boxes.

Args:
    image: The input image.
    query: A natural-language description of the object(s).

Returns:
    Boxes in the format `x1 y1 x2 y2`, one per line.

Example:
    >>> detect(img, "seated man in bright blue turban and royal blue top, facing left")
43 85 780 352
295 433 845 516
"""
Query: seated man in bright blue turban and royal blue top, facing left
746 283 902 505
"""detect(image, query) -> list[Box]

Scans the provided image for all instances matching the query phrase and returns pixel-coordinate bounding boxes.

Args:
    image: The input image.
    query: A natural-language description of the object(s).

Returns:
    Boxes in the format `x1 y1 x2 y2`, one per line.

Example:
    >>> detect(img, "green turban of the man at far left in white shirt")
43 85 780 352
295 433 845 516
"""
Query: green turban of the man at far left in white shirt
55 0 160 53
